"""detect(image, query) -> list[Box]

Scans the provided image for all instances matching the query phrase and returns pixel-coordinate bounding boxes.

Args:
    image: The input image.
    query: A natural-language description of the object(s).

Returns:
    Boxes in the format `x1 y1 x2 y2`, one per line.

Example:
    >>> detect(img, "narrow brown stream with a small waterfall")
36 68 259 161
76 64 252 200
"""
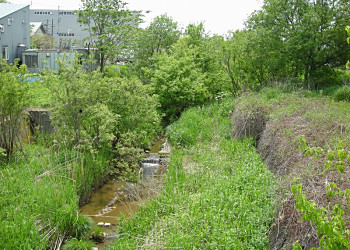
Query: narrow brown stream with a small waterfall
81 139 169 249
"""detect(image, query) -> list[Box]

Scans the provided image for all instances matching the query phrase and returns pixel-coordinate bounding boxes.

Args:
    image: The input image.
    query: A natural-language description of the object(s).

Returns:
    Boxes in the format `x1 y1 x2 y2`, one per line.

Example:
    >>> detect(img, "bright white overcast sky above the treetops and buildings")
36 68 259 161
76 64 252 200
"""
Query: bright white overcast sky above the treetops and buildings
9 0 262 35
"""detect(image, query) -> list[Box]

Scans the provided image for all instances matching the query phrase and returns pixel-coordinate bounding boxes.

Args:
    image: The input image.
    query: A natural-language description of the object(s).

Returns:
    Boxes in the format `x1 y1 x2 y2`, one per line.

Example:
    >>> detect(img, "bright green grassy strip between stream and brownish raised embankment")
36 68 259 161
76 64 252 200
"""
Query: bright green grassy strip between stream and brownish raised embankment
112 99 275 249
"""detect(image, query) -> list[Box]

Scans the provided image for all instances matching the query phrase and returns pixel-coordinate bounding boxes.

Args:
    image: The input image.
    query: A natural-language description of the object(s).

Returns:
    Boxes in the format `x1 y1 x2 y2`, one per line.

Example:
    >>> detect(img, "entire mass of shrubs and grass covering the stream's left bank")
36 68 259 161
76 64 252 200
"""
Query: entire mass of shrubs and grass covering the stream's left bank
0 55 160 249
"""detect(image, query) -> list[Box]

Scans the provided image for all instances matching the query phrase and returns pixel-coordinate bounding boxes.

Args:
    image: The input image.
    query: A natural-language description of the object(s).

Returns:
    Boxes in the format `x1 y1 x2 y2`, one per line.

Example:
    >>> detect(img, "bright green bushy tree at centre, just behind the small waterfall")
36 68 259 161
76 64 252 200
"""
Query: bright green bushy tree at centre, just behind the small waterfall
151 38 210 121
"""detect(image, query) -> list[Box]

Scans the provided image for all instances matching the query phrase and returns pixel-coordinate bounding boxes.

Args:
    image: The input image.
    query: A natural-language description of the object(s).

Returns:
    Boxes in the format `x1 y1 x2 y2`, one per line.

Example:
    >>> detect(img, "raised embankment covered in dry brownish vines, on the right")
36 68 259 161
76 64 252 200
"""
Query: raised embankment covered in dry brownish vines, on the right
233 86 350 249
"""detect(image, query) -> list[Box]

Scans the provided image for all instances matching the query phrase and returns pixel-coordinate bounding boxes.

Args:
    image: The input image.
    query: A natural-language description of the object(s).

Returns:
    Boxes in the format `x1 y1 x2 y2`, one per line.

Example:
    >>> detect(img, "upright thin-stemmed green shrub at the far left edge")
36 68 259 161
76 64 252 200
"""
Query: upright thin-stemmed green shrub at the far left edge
0 60 28 157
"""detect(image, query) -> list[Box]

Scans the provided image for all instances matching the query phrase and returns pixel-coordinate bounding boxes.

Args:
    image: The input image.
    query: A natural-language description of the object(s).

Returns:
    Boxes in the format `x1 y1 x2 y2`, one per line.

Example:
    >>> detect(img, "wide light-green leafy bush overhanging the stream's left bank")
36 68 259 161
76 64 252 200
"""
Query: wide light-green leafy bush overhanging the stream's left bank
43 56 160 150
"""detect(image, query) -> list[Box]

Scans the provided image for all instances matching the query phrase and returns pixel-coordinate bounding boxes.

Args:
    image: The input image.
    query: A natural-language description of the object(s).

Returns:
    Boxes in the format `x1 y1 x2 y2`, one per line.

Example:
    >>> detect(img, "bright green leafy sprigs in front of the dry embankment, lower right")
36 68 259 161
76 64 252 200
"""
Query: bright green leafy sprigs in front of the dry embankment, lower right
291 137 350 249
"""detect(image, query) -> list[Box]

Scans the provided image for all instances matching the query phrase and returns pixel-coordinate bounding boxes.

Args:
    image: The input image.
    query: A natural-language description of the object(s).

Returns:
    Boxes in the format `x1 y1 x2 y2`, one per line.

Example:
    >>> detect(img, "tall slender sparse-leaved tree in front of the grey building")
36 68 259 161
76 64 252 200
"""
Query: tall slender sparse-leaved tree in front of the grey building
78 0 141 72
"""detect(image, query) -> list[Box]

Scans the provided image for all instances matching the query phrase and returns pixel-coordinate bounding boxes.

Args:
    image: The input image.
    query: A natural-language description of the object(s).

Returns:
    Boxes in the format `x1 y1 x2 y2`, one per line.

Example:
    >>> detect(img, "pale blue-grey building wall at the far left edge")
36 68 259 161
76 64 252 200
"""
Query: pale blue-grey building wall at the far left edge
0 5 30 63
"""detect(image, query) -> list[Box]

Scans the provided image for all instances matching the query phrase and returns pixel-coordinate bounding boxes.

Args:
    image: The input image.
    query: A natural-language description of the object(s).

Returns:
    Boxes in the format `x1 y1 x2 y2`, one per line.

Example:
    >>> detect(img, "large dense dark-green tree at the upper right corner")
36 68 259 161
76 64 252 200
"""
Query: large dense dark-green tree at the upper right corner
248 0 350 87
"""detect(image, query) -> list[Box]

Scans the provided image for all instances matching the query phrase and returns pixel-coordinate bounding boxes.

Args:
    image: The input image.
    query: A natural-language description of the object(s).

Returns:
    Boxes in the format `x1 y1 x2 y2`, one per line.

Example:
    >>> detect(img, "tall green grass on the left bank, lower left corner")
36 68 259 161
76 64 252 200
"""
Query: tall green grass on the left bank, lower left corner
0 145 108 249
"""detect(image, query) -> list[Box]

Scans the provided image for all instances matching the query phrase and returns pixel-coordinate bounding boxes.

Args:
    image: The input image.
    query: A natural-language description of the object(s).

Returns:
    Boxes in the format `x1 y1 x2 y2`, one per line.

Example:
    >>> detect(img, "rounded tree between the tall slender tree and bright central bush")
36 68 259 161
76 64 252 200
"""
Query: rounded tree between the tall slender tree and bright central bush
132 15 181 83
